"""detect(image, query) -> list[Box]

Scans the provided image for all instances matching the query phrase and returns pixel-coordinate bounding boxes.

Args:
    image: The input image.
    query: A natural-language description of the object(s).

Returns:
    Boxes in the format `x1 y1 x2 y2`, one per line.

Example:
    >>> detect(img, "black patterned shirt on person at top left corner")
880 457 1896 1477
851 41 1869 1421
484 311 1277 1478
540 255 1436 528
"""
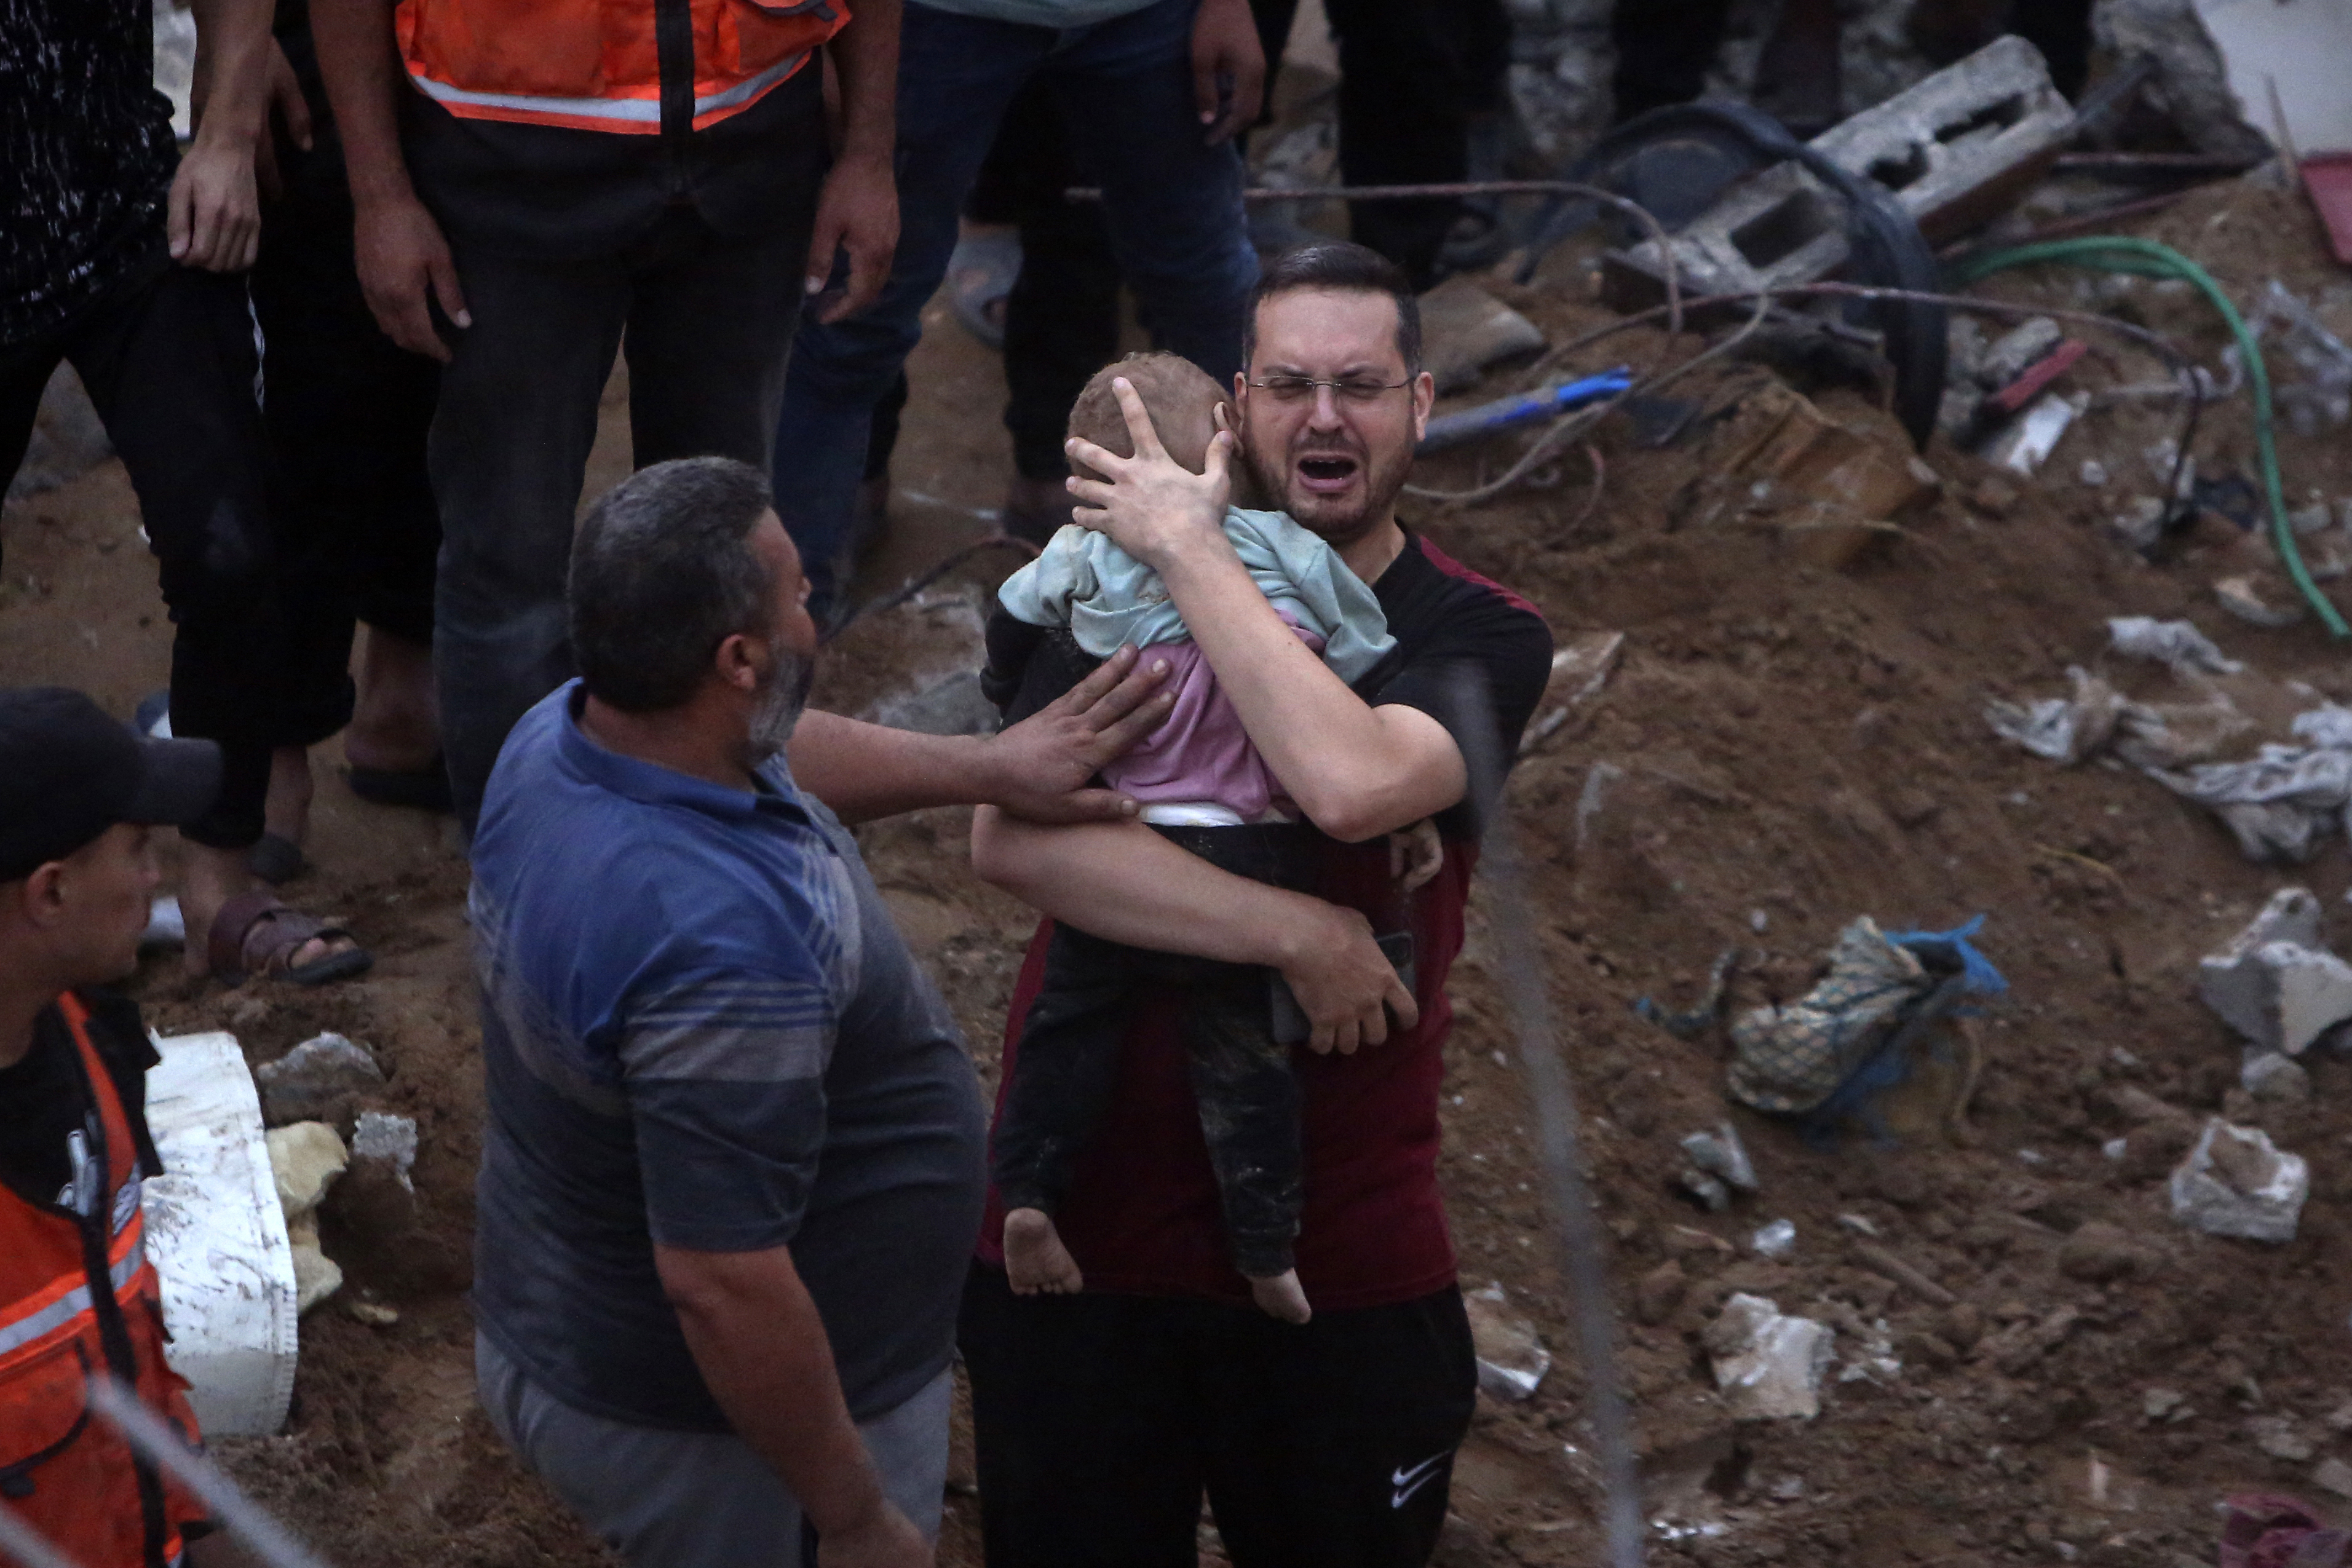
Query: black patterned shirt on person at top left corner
0 0 179 346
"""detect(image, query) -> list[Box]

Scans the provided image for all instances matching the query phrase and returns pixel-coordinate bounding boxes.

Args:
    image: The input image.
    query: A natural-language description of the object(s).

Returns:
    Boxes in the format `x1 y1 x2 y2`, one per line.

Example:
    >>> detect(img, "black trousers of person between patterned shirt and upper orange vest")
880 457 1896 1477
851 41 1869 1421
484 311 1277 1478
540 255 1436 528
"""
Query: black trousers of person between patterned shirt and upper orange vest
251 55 440 743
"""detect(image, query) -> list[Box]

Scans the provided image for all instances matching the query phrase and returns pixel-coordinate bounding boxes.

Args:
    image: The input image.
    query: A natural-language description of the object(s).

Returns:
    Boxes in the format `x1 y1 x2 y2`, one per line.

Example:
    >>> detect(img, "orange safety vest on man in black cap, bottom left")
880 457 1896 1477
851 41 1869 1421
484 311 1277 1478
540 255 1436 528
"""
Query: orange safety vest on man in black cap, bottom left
0 994 205 1568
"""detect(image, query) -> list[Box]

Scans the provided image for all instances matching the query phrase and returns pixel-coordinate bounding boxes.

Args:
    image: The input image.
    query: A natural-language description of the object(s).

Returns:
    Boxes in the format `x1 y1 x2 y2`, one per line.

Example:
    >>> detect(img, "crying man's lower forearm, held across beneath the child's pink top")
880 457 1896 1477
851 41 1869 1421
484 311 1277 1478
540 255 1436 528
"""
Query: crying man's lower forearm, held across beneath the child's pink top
972 806 1334 968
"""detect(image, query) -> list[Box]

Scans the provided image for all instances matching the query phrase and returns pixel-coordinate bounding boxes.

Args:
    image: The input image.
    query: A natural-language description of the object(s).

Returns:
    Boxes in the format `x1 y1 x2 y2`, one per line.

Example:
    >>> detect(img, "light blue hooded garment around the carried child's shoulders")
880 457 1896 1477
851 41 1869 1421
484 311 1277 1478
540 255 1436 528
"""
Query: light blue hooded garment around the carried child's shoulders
997 508 1397 684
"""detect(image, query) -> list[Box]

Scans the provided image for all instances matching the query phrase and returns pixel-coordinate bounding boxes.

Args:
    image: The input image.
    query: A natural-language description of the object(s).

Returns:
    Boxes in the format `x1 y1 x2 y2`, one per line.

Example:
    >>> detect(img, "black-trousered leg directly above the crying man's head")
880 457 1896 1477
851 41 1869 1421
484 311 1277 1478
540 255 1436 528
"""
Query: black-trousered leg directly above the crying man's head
1326 0 1472 289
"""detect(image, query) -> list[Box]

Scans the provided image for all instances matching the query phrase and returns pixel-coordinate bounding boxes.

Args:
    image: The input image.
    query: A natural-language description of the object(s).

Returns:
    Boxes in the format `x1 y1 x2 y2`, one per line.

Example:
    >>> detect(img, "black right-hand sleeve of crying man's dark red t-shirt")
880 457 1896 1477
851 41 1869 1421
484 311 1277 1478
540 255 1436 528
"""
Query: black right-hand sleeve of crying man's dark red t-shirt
1364 590 1553 837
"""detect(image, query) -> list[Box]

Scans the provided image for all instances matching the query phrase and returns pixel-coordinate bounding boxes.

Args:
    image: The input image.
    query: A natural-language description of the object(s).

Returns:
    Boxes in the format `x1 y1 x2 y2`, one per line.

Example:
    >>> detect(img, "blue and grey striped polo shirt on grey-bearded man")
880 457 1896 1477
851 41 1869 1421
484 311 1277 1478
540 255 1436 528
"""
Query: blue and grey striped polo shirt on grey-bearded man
470 684 981 1431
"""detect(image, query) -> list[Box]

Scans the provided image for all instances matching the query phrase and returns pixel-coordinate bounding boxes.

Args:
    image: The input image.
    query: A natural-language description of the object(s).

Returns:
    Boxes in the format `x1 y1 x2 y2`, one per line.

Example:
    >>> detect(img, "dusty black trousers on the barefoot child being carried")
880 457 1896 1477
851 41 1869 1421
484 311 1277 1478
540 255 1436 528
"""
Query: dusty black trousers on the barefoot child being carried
990 825 1315 1279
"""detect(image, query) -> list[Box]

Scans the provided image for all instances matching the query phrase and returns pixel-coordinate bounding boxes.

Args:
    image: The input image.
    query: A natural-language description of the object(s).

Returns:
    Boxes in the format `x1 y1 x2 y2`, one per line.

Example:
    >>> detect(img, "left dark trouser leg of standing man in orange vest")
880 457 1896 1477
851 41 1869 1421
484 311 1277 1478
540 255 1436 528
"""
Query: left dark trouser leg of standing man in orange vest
426 232 628 834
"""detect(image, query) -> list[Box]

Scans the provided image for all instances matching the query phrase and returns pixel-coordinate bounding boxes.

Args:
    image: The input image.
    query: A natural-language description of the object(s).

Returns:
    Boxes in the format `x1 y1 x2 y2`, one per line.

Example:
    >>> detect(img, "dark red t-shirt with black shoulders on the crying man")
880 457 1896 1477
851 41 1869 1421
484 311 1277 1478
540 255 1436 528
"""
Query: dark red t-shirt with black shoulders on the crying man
981 536 1553 1312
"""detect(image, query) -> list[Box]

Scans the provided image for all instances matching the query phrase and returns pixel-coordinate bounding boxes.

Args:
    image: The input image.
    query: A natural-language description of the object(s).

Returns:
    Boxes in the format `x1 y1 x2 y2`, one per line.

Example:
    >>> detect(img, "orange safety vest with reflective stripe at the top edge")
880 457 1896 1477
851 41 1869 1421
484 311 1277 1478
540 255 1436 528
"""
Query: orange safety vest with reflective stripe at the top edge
393 0 849 137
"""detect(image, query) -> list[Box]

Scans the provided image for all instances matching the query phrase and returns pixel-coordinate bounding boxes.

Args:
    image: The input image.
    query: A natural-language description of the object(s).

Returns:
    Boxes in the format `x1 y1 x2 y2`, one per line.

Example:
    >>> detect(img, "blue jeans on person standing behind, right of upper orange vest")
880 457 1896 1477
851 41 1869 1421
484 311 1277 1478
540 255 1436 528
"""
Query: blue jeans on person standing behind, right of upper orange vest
774 0 1258 616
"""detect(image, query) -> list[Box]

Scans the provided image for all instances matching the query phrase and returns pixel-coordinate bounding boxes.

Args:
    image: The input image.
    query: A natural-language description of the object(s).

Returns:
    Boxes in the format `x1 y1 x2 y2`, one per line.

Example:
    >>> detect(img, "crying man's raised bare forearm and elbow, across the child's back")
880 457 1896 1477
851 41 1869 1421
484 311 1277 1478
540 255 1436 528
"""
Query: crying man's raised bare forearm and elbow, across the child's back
1162 538 1468 839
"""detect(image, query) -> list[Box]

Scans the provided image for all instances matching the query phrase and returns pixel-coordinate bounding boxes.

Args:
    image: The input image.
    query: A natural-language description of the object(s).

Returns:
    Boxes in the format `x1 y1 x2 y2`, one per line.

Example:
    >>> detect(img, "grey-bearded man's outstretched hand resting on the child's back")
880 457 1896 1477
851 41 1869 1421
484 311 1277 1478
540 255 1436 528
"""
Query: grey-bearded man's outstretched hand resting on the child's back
986 649 1176 825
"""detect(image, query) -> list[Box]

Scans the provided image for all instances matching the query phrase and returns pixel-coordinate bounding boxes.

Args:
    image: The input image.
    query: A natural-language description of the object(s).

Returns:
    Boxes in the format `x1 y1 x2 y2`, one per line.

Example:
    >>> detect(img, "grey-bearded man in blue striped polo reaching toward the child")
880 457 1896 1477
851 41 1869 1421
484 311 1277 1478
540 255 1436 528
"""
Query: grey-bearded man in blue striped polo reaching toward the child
470 459 1164 1568
